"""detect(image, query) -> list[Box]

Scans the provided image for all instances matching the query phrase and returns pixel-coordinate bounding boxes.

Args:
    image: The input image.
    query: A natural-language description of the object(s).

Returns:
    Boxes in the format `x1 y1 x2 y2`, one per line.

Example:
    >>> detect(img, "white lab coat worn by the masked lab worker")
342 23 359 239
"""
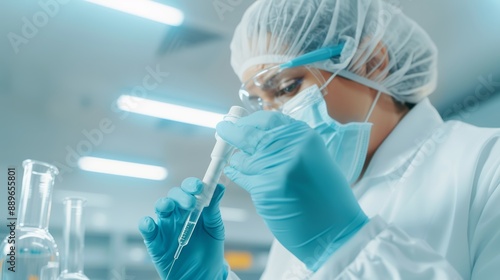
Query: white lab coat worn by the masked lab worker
228 99 500 280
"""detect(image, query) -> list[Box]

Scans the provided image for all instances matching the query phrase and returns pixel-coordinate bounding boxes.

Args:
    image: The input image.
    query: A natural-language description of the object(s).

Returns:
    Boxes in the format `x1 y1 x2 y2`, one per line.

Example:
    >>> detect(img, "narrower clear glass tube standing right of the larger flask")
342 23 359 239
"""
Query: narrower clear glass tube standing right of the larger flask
57 197 89 280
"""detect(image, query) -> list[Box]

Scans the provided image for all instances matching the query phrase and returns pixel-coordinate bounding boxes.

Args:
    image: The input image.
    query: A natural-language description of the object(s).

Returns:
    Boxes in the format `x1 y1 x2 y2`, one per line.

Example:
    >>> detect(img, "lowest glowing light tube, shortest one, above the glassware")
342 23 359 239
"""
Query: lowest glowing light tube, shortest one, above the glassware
78 157 168 181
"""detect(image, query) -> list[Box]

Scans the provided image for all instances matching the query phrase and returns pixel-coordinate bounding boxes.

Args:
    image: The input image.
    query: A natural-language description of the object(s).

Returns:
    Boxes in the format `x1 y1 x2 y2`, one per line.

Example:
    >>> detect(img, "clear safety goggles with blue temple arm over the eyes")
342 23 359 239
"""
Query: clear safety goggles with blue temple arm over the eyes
239 43 344 112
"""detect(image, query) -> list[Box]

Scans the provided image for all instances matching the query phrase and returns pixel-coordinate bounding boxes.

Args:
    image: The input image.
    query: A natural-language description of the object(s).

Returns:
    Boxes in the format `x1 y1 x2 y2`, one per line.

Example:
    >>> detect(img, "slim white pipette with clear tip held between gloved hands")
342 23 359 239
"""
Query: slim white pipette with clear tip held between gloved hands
167 106 248 279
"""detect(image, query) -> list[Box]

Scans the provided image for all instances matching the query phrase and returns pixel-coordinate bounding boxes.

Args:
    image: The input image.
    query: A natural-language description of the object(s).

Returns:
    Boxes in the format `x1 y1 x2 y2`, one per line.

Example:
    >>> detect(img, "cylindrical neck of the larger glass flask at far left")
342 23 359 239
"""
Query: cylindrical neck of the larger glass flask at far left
18 161 57 230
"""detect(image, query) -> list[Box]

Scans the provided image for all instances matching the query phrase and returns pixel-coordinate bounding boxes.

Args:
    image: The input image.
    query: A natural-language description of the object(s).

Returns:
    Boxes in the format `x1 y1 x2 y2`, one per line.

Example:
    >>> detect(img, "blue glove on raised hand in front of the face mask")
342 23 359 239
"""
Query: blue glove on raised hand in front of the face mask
217 111 368 271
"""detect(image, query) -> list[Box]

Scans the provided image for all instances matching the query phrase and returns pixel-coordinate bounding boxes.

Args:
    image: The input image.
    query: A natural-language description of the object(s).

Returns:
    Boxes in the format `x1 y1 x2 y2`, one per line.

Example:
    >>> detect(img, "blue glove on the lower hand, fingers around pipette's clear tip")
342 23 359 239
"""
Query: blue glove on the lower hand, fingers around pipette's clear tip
139 178 228 280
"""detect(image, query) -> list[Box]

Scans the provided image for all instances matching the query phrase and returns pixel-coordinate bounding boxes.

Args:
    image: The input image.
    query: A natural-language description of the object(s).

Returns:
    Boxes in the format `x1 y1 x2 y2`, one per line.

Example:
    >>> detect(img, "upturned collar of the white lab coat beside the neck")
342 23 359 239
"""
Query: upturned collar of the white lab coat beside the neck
362 98 443 180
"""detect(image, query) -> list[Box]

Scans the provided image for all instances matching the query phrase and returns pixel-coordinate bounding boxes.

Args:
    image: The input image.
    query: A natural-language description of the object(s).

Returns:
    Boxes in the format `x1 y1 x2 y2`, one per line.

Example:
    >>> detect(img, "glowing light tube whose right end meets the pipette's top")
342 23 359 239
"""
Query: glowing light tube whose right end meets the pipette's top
117 95 224 128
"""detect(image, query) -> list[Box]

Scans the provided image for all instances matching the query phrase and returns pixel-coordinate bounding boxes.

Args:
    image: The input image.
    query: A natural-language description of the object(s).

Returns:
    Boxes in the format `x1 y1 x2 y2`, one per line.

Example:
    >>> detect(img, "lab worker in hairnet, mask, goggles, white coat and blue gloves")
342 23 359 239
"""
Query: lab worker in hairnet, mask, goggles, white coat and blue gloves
139 0 500 280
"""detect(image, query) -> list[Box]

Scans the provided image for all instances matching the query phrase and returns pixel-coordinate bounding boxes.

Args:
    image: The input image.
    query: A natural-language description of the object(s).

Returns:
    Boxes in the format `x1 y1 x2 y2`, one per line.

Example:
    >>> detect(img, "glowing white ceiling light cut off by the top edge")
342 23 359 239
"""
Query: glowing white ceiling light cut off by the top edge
86 0 184 26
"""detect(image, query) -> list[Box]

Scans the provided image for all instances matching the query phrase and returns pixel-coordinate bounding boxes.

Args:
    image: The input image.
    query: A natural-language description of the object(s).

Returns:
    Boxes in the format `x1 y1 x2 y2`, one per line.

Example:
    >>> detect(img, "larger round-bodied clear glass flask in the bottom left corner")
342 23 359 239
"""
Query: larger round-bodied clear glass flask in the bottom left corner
0 160 59 280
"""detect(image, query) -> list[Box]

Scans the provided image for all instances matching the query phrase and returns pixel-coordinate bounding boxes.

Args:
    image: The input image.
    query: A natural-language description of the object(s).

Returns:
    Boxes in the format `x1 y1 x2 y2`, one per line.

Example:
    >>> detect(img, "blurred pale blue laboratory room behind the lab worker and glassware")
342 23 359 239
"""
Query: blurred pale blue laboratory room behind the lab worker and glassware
0 0 500 280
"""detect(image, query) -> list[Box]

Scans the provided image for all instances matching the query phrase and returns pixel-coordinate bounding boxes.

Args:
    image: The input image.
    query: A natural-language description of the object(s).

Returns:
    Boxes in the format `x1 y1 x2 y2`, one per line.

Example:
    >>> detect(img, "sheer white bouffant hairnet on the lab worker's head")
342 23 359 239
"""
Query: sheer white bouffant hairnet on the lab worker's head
231 0 437 103
